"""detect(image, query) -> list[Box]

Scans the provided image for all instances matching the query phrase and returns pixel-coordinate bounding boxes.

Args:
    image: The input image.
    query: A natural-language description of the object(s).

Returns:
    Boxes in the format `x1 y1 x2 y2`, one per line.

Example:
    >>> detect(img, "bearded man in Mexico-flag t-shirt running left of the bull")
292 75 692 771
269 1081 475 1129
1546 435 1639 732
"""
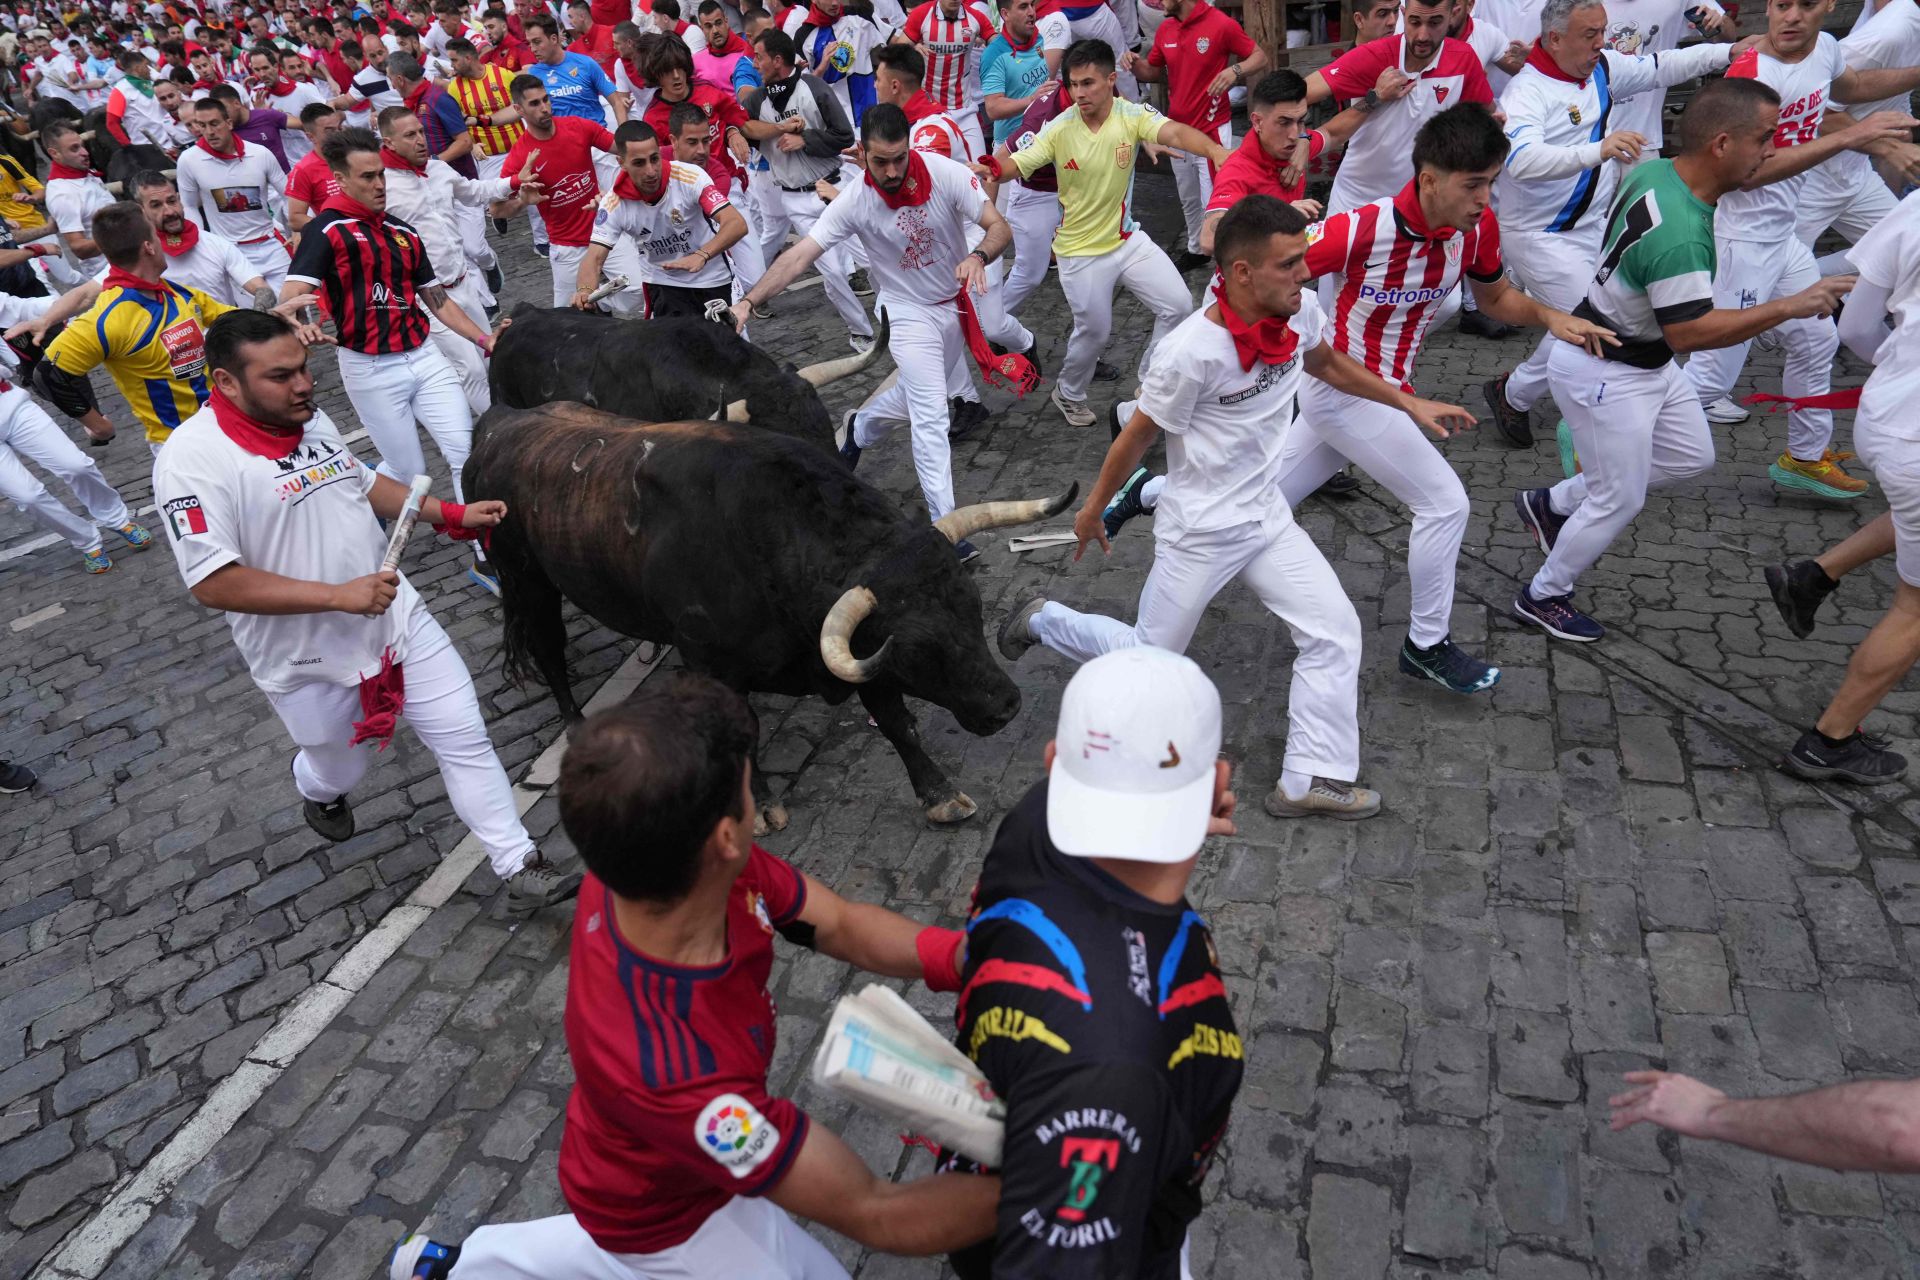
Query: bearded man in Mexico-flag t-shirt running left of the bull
154 311 578 913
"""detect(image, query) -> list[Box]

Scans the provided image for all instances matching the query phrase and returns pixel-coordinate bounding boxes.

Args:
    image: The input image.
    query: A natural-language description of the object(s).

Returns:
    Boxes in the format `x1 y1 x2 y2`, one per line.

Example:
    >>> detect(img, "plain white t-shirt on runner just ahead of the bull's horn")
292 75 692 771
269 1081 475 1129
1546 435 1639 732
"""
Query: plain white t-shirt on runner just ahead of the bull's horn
1140 290 1327 541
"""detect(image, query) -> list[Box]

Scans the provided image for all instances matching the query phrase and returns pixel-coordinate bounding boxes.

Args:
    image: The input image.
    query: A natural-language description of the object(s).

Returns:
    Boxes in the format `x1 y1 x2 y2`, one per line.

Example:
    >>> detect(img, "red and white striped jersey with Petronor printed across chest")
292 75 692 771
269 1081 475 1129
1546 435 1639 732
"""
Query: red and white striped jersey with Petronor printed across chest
1308 182 1505 393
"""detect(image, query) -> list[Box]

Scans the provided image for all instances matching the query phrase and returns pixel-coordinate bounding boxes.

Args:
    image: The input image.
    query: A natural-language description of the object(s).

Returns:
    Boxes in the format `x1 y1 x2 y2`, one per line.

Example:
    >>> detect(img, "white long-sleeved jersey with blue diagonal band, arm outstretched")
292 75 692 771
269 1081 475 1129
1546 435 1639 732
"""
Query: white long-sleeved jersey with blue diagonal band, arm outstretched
1494 44 1732 244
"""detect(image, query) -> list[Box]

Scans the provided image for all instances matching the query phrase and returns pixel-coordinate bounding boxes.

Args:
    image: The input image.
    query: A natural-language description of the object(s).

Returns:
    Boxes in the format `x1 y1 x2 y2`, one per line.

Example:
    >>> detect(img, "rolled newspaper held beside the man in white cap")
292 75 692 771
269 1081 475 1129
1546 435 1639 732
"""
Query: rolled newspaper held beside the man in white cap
812 986 1006 1167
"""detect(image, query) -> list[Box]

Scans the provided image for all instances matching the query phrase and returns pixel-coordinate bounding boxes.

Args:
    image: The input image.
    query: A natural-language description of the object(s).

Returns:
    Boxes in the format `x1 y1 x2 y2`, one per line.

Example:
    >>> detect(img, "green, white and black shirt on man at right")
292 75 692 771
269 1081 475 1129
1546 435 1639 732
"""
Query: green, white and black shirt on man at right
1574 159 1715 368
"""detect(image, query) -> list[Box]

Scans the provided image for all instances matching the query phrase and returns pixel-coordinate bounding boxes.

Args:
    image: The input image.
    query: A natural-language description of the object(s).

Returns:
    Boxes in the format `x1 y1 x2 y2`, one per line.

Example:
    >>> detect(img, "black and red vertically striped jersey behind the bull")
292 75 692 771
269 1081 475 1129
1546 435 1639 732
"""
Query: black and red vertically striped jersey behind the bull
286 205 440 355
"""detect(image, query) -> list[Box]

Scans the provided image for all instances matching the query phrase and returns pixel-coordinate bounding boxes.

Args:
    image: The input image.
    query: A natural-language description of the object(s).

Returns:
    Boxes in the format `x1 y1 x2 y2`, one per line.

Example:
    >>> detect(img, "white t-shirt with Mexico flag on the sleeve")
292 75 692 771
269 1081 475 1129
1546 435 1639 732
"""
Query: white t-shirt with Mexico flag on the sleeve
154 405 420 693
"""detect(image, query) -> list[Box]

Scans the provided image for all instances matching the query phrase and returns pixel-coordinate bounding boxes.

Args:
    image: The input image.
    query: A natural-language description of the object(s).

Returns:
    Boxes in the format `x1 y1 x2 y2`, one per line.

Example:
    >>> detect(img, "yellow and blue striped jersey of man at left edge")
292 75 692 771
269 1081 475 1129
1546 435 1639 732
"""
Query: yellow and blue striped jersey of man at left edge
46 280 232 443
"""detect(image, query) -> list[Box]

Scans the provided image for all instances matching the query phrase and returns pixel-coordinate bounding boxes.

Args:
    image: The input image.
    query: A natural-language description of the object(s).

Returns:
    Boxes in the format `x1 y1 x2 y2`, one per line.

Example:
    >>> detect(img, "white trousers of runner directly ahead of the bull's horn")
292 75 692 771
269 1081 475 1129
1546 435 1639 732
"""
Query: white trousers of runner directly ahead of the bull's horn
1033 505 1359 781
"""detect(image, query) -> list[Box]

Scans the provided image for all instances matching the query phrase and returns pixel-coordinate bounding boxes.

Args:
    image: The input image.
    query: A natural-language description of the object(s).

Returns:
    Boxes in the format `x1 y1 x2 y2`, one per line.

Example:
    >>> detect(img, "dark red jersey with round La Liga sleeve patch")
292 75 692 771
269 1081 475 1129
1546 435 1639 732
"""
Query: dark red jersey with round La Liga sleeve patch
561 846 806 1253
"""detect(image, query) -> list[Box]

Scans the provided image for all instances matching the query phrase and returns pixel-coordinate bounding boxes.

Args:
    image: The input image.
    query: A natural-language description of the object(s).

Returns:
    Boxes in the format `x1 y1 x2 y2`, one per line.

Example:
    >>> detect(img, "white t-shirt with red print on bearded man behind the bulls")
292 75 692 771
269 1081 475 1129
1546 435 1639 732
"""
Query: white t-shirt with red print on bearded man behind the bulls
806 152 990 305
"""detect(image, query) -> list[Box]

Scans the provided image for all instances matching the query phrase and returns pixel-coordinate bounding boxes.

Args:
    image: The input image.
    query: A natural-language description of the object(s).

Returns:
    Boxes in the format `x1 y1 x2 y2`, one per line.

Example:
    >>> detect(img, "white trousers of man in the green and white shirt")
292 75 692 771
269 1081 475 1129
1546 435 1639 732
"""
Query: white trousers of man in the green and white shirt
1532 342 1713 597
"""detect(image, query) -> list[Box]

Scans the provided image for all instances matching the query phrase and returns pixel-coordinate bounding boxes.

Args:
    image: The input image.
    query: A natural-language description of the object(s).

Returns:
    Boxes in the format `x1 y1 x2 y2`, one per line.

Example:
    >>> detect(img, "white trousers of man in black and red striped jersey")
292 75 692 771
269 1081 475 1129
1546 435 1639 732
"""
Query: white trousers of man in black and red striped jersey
340 342 474 503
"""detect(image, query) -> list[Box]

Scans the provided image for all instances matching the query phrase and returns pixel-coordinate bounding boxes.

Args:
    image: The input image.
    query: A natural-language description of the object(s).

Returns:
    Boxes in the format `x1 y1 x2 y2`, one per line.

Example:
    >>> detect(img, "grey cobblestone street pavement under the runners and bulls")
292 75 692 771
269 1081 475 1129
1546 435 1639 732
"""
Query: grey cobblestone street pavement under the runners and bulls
0 160 1920 1280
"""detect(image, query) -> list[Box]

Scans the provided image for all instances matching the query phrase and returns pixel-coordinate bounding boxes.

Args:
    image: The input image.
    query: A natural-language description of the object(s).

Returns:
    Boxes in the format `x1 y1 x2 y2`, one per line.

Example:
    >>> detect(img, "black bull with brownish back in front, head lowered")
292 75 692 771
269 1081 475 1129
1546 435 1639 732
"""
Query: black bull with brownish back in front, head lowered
463 403 1077 827
